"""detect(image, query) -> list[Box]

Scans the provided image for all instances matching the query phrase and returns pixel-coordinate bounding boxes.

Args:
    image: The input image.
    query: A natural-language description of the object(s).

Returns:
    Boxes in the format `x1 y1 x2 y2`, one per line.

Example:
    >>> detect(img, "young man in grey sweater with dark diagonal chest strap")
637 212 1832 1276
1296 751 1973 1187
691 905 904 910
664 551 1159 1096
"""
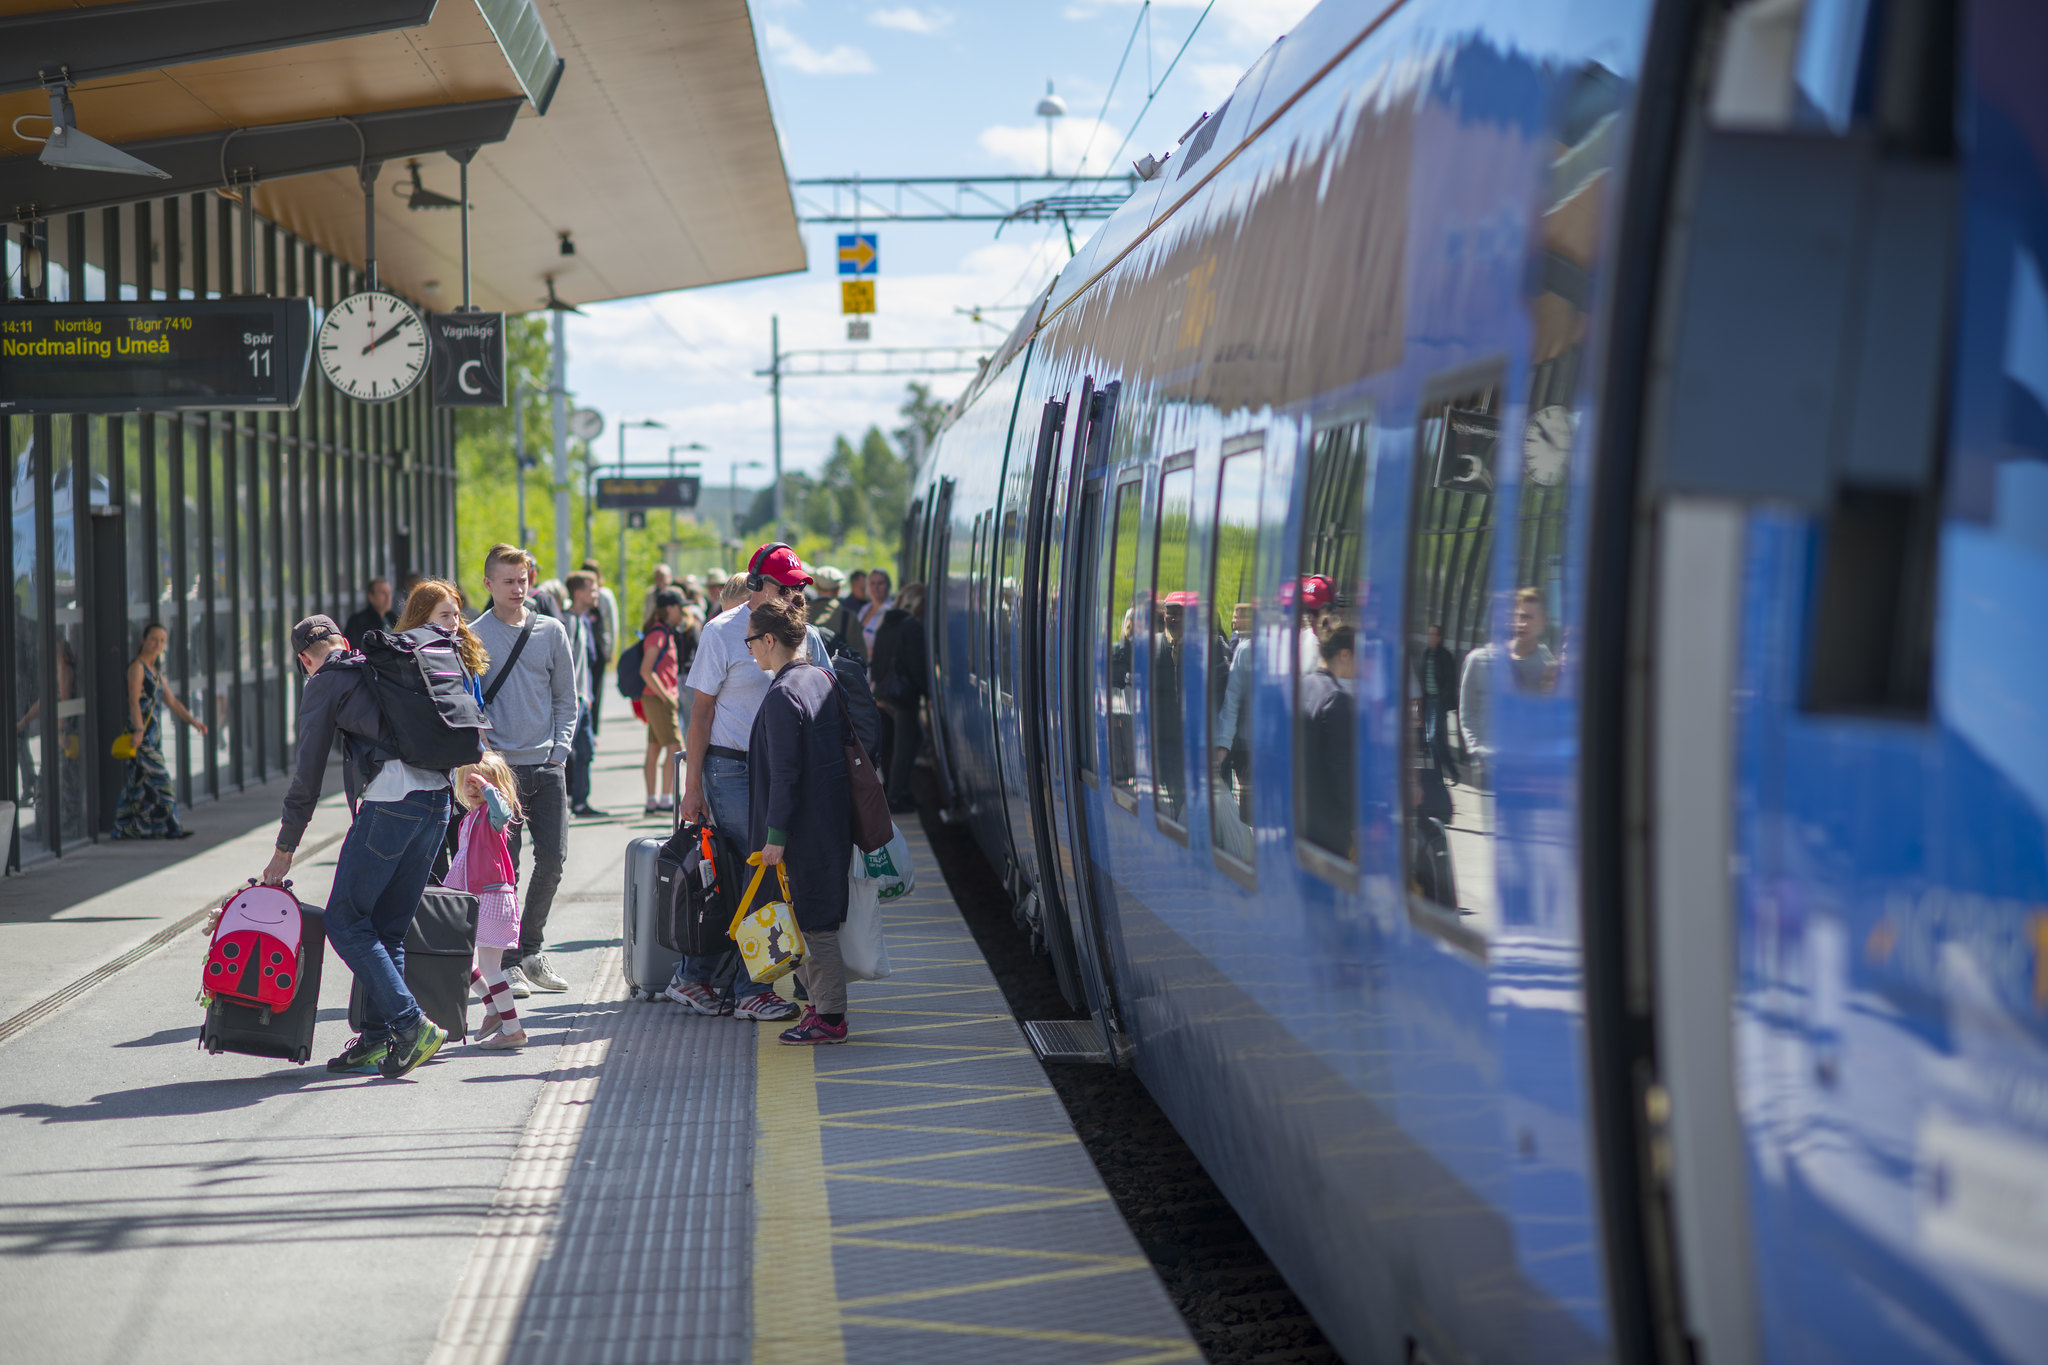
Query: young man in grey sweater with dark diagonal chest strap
469 544 578 997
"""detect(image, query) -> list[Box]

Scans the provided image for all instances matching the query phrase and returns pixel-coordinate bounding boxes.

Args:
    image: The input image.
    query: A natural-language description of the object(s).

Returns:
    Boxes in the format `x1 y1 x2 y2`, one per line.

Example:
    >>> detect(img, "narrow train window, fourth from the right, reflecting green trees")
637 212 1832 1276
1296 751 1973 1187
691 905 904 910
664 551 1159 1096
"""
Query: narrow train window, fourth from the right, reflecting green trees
1147 450 1202 837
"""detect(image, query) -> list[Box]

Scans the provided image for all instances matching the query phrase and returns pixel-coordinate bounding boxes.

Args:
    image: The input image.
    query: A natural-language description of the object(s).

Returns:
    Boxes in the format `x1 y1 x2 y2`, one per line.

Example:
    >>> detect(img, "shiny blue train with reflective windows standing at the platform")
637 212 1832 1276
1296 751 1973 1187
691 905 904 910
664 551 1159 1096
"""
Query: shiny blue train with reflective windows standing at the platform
903 0 2048 1365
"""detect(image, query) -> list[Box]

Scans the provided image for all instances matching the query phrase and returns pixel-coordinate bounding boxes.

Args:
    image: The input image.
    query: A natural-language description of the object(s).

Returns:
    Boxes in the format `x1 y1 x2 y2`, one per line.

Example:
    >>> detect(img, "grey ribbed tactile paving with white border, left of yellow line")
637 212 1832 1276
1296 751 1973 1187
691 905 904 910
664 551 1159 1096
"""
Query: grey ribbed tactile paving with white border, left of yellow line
432 950 758 1365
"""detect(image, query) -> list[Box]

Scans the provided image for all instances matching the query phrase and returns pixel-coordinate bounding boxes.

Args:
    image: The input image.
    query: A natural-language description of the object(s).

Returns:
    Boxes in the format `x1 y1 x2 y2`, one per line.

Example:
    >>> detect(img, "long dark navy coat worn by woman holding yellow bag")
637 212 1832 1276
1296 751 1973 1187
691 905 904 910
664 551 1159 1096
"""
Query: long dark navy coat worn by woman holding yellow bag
748 655 854 929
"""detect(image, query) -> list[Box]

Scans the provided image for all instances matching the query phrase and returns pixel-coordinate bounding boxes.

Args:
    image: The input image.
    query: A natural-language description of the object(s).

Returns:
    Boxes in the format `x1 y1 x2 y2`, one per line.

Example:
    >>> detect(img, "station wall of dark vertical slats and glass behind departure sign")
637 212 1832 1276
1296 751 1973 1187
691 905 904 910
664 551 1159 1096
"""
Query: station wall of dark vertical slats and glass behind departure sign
0 192 455 868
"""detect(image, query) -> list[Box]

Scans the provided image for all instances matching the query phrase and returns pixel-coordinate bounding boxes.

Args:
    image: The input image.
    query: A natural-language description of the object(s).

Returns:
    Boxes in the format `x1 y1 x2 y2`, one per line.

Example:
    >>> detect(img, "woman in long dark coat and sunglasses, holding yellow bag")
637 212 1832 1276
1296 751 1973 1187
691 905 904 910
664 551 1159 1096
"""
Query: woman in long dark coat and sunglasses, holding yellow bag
748 600 854 1044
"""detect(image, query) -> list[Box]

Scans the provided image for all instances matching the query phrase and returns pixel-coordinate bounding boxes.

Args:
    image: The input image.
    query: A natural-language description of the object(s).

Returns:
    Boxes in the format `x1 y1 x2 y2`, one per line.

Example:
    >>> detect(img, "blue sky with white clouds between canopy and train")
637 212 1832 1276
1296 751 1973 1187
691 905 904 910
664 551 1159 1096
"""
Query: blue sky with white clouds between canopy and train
567 0 1313 499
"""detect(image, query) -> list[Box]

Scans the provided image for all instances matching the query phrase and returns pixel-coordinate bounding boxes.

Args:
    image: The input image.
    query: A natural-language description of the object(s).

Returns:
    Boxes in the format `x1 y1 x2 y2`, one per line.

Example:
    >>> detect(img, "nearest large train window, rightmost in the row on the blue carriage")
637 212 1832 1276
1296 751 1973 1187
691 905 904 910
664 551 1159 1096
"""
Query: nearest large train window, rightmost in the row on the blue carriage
1403 368 1507 952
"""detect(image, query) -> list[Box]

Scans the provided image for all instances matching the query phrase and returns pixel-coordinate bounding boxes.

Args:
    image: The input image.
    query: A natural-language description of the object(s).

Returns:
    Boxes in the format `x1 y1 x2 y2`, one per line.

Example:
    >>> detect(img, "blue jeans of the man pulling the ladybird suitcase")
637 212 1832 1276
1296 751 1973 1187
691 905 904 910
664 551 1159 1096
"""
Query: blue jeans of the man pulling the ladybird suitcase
326 788 451 1040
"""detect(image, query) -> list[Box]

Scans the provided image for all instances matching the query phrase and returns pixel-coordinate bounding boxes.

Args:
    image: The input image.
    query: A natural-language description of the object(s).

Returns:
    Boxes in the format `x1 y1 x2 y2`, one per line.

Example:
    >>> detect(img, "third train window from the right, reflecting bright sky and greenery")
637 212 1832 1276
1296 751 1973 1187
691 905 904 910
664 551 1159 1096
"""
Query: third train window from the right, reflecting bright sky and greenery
1208 432 1266 872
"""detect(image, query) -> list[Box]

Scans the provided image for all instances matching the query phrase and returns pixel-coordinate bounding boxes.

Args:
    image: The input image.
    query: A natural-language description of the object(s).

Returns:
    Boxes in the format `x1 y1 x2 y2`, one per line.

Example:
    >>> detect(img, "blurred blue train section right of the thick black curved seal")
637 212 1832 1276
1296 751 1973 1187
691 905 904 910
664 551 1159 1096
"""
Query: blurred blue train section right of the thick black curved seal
1624 0 2048 1365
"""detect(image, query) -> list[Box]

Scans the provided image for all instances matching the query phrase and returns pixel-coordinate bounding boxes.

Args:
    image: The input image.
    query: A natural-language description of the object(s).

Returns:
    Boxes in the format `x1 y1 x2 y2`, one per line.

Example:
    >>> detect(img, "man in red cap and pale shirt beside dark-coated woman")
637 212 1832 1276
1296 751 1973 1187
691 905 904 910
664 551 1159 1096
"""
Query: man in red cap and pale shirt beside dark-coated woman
664 542 811 1019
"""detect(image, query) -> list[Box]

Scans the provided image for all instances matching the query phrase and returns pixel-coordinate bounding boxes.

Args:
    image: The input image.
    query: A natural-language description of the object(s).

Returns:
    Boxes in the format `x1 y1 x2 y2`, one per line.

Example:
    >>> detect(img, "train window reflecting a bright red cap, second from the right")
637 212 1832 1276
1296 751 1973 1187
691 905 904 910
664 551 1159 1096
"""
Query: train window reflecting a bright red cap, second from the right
1280 420 1372 886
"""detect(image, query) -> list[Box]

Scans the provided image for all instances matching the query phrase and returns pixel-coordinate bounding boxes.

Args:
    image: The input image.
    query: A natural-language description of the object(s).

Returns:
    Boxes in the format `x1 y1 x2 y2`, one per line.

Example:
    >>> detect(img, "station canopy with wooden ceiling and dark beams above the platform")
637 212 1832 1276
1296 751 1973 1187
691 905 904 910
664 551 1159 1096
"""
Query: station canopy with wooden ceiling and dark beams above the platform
0 0 805 313
